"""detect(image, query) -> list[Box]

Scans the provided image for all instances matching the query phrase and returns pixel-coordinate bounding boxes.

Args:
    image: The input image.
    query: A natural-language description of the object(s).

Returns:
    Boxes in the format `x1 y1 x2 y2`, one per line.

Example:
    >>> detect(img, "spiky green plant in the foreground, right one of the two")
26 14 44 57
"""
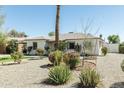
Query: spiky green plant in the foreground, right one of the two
79 68 100 88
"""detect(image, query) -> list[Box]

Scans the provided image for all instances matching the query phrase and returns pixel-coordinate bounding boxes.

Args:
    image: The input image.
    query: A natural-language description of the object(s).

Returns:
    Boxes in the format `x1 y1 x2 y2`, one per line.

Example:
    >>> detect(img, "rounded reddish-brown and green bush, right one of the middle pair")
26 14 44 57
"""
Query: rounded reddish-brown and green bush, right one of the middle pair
63 52 80 69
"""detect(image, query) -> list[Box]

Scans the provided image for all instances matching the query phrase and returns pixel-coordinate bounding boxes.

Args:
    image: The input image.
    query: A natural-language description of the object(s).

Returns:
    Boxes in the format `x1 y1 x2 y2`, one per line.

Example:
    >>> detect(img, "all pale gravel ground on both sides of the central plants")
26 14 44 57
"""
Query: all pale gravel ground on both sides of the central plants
0 54 124 88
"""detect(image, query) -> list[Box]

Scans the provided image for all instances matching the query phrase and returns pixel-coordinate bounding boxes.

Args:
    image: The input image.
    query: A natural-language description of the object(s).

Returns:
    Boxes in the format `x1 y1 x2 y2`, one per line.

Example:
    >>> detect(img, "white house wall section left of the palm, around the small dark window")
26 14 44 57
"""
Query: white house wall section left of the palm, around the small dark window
25 40 46 54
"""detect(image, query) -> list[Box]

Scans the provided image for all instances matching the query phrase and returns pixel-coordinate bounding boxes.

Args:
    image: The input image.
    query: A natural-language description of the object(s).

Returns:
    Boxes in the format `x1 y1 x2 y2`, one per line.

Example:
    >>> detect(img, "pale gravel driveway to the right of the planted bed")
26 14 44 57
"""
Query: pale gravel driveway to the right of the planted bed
97 53 124 88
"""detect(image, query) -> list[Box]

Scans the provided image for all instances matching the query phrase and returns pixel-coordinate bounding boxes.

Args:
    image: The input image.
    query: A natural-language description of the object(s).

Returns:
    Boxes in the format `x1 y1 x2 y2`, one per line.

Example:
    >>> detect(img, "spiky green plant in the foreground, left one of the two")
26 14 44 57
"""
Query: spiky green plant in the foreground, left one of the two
48 65 71 85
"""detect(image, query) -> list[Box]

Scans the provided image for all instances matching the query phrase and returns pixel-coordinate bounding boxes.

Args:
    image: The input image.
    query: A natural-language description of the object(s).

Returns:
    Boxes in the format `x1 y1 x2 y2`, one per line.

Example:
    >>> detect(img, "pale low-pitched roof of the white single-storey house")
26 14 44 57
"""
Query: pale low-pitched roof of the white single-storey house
25 33 100 41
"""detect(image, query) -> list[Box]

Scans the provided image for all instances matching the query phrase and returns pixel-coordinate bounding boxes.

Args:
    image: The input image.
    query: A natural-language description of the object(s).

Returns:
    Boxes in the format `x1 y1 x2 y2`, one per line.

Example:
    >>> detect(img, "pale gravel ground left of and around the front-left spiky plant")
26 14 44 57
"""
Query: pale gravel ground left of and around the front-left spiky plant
0 58 78 88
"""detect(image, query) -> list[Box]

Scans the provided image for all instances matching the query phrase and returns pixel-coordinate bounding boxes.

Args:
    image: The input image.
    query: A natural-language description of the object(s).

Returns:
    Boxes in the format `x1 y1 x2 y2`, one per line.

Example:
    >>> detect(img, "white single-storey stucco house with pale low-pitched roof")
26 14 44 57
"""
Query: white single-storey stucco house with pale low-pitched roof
25 32 104 55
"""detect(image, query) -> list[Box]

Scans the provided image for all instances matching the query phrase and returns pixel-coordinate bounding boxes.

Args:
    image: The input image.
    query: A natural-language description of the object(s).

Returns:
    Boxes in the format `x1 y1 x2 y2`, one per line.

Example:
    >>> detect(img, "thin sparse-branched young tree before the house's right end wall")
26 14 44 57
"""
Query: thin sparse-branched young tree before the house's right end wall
82 19 100 66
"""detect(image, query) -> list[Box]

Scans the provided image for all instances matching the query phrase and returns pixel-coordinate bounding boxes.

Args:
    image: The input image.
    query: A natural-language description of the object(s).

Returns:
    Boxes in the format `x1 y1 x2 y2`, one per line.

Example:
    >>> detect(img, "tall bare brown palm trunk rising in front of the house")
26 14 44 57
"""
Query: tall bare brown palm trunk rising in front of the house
55 5 60 49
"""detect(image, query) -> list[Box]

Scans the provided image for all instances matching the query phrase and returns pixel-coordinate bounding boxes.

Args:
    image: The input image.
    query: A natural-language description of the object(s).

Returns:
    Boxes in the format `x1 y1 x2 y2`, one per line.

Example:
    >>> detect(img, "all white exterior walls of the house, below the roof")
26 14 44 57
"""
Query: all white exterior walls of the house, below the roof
26 39 102 55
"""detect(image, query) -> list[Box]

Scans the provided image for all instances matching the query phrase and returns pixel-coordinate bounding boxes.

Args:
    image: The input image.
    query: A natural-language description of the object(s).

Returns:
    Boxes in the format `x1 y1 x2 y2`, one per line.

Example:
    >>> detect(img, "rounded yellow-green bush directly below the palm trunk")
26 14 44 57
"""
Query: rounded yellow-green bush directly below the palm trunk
49 50 63 66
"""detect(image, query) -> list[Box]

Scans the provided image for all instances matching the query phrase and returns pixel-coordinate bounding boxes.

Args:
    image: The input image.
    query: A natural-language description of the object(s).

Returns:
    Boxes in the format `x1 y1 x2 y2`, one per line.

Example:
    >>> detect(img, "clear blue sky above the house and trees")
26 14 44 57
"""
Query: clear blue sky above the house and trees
3 5 124 41
